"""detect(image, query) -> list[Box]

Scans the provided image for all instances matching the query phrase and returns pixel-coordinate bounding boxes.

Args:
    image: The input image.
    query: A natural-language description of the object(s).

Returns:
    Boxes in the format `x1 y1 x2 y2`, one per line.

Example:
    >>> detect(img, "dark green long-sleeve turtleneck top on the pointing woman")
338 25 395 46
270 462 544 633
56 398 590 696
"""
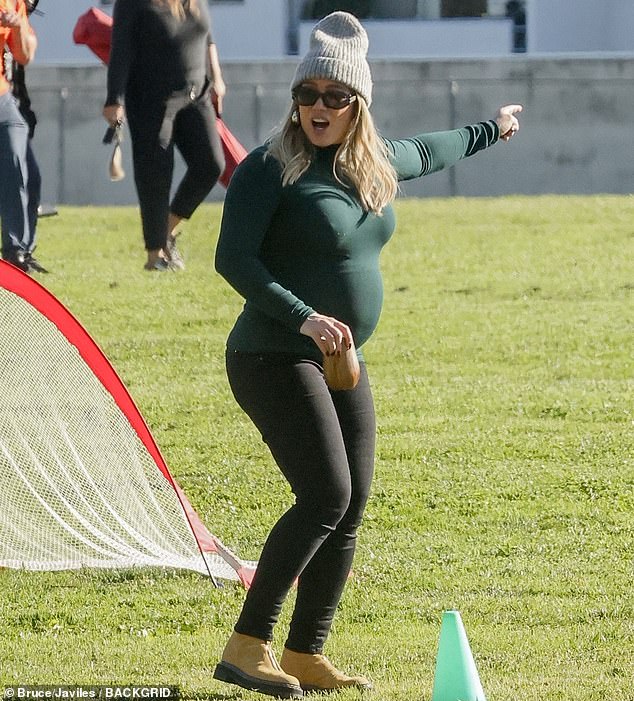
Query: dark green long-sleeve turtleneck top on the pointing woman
216 121 499 362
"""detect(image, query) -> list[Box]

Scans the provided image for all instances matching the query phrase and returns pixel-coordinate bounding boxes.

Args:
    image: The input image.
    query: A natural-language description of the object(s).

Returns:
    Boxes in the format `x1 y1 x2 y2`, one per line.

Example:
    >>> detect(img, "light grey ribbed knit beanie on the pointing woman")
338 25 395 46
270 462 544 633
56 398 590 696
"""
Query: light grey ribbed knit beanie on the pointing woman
291 12 372 106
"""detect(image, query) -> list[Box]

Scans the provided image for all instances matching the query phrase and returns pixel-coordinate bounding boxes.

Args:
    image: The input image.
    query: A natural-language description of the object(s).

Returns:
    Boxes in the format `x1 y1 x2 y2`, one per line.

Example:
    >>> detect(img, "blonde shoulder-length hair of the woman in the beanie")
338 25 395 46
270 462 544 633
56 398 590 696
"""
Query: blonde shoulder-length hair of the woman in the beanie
268 96 398 215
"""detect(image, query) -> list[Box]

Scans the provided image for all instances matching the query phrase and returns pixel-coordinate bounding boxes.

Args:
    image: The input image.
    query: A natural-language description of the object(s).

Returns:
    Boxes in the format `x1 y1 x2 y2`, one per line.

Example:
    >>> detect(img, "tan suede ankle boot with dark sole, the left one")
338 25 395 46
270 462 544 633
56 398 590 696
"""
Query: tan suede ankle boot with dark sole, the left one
214 632 303 699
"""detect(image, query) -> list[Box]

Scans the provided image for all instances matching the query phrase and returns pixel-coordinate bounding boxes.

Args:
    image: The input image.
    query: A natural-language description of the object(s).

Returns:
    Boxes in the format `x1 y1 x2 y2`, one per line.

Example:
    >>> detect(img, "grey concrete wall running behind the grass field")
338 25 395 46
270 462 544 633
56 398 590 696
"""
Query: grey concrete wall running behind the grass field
27 55 634 204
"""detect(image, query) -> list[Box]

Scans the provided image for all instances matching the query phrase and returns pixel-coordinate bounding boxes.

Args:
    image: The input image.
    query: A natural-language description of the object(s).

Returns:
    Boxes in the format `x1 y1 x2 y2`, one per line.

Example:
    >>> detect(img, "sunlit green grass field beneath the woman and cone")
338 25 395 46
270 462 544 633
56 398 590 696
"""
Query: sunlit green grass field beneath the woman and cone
0 196 634 701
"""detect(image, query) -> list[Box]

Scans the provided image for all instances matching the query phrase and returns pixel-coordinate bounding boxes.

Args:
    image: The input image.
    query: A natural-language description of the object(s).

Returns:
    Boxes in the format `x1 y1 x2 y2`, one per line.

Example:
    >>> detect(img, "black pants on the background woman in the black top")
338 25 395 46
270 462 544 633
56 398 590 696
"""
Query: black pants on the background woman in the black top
126 92 225 251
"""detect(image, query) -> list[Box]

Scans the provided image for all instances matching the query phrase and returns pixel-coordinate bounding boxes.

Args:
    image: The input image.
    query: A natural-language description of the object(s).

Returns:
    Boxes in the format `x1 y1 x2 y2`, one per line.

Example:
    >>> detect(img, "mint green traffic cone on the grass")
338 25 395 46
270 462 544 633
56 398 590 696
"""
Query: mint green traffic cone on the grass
432 611 486 701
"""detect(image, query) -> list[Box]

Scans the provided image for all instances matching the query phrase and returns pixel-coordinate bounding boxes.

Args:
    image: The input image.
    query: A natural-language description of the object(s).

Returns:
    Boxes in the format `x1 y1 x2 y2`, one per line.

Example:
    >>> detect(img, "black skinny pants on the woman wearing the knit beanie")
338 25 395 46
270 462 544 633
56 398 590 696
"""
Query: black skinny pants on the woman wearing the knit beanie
227 352 376 653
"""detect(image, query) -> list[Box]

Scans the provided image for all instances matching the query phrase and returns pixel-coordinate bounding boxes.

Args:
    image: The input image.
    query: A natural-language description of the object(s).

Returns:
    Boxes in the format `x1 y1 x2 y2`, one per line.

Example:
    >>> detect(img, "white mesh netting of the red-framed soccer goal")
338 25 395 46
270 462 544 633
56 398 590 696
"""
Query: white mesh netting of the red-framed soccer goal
0 269 255 579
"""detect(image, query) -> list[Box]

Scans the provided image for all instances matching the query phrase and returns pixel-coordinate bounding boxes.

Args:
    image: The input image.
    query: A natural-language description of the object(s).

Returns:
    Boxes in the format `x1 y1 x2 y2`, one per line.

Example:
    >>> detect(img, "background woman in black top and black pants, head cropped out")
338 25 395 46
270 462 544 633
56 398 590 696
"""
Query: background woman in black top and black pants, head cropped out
103 0 225 271
